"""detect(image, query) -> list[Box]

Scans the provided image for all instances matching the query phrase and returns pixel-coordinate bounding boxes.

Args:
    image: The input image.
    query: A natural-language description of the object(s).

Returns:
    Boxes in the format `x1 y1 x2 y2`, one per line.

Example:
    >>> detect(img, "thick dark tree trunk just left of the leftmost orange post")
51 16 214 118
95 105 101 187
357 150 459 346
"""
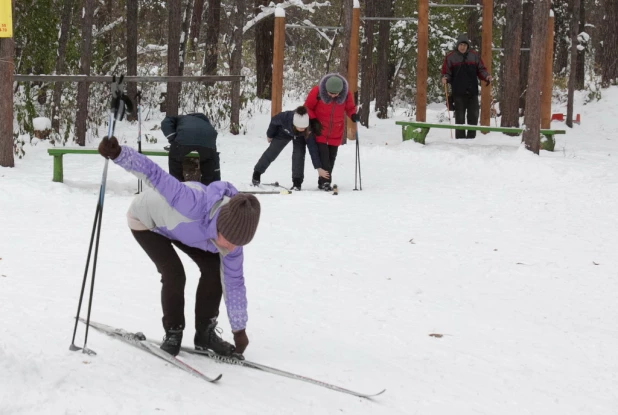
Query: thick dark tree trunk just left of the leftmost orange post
254 0 275 100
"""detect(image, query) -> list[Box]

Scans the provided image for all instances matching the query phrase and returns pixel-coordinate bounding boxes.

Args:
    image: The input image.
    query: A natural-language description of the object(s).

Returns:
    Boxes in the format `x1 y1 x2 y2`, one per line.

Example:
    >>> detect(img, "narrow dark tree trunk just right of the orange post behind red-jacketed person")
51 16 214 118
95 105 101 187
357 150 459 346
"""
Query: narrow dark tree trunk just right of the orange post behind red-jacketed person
359 0 376 127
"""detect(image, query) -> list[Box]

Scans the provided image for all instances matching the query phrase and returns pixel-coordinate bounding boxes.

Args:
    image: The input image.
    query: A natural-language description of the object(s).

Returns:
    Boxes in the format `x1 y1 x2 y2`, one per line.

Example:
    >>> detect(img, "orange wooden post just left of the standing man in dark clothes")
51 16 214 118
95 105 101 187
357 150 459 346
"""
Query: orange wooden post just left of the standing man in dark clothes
416 0 429 122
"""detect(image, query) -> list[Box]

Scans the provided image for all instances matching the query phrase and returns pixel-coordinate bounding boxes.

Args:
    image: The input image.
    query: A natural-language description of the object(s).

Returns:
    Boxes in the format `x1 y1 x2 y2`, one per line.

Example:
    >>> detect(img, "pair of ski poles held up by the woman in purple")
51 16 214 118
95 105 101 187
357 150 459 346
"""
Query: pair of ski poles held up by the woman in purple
69 75 132 355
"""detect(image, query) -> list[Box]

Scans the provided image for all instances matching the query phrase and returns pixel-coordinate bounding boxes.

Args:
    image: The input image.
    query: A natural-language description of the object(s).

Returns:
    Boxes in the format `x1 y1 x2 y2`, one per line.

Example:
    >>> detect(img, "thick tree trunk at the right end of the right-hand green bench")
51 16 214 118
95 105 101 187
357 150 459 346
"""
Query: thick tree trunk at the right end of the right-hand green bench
500 0 522 127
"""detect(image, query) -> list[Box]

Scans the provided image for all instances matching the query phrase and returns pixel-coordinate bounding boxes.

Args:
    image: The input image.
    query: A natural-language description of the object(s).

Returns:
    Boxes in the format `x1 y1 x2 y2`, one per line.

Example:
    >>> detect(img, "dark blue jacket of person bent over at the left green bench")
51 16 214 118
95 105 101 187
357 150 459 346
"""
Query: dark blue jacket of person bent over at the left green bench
161 113 217 150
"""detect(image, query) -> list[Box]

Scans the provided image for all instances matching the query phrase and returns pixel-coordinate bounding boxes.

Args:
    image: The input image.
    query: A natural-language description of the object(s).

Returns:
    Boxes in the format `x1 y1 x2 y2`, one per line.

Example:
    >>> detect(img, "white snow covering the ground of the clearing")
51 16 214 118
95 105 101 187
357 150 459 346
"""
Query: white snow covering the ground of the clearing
0 87 618 415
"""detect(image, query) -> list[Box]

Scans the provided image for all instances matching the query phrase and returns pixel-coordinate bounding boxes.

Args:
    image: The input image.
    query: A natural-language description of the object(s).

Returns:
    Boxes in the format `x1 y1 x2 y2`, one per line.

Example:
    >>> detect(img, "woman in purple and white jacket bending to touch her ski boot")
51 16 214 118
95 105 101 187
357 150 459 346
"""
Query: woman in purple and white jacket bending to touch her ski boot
99 137 260 356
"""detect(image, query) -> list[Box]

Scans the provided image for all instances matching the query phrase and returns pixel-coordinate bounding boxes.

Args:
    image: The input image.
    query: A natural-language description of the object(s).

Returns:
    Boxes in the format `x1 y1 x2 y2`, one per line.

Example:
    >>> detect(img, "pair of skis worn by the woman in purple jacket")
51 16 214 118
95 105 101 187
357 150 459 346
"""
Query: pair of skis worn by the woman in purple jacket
80 318 386 398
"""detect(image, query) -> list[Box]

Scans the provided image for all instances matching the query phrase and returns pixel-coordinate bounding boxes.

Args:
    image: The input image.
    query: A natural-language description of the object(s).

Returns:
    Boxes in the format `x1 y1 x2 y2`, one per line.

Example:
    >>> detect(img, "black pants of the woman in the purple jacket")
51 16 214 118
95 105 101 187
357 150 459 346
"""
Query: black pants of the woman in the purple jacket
131 230 223 331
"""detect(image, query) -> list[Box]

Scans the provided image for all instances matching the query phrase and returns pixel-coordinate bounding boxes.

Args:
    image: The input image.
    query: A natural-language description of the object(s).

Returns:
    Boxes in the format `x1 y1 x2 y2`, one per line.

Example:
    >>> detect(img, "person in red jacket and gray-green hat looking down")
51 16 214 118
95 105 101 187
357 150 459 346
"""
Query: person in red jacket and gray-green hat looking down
305 73 358 191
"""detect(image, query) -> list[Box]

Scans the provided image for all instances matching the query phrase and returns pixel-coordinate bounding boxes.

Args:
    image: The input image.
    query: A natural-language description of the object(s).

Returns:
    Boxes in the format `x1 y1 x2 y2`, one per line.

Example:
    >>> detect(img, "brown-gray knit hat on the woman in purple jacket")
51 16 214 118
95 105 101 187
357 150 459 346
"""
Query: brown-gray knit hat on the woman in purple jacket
217 193 260 246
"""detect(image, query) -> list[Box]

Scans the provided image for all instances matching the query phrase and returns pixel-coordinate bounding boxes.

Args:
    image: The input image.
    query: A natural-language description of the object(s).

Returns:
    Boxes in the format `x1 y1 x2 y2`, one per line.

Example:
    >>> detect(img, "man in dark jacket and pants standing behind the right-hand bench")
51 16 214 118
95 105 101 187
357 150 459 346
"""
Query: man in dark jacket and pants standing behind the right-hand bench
442 34 492 138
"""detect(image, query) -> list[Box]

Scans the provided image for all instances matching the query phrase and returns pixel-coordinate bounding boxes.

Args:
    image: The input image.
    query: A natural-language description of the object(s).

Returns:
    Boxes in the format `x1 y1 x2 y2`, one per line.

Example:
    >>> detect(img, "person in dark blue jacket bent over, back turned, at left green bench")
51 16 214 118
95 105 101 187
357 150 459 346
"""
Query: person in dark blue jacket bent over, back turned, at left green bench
161 113 221 185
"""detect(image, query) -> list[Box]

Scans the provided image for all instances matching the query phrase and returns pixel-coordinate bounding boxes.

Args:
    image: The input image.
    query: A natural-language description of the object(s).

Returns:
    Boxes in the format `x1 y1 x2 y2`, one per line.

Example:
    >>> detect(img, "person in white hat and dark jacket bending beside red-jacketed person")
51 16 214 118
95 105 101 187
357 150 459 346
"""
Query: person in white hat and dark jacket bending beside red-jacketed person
252 106 329 190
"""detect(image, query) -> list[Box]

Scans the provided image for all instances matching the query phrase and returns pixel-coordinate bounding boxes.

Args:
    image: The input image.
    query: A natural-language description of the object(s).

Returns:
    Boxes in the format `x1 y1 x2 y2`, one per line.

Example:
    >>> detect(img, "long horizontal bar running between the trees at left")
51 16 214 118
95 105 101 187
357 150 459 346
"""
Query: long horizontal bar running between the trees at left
13 75 245 82
